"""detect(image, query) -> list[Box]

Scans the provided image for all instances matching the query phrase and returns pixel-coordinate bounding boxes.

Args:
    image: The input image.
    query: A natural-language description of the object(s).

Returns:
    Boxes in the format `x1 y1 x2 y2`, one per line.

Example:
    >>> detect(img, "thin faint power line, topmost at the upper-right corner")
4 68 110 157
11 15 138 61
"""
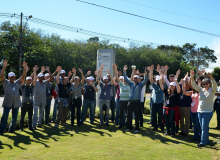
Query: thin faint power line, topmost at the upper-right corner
122 0 220 23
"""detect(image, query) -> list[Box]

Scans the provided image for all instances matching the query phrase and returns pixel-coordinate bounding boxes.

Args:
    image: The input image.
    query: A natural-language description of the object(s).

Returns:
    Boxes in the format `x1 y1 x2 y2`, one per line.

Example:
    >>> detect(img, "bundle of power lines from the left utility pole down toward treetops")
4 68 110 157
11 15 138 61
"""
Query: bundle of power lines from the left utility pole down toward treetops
0 13 160 46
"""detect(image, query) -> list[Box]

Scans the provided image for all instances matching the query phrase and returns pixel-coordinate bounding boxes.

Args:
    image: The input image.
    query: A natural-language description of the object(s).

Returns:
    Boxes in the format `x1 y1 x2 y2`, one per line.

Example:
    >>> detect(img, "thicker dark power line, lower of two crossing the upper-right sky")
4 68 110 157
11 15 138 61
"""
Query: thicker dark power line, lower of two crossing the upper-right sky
76 0 220 37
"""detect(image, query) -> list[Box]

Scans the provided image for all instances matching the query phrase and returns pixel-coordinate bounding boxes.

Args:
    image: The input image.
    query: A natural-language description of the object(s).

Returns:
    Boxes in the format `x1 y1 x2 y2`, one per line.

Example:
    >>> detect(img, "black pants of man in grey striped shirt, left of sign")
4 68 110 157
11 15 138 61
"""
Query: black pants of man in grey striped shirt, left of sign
70 97 82 124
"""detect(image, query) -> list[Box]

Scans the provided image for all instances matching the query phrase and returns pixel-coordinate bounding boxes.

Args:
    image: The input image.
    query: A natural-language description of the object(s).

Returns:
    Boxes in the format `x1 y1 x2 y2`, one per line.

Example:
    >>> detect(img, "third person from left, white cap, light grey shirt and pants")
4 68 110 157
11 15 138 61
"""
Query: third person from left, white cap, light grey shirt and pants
33 66 52 129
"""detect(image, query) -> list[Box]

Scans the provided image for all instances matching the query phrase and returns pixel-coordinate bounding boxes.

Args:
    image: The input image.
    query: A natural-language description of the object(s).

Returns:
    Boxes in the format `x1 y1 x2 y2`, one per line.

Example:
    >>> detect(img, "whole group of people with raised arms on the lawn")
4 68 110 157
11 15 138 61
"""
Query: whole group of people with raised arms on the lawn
0 60 220 147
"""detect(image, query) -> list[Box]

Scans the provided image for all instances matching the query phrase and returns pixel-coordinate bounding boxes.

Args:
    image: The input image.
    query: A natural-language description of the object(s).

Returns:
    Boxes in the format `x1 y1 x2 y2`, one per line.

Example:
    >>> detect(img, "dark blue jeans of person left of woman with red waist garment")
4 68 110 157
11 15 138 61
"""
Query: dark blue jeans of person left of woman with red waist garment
151 102 164 130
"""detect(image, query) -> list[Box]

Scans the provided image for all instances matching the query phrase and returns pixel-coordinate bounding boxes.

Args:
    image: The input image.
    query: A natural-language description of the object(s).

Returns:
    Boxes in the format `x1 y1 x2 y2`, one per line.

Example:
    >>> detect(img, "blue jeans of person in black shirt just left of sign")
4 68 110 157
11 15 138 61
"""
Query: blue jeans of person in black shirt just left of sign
81 100 95 124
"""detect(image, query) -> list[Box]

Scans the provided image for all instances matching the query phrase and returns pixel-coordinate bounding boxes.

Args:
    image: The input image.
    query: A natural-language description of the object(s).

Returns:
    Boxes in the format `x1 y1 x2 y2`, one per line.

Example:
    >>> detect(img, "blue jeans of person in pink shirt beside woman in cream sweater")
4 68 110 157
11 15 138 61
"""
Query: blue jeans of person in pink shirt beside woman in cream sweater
190 111 201 141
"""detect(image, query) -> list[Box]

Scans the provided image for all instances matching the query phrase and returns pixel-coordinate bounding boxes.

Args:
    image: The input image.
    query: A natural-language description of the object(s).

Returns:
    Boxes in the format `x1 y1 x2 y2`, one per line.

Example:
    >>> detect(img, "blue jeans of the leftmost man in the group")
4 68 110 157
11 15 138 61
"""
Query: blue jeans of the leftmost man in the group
0 105 19 133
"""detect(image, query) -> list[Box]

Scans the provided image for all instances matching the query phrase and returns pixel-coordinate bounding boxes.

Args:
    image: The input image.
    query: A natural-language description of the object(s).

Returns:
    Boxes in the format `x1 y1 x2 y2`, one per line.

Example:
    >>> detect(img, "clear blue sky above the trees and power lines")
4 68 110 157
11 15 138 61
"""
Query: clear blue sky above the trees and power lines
0 0 220 68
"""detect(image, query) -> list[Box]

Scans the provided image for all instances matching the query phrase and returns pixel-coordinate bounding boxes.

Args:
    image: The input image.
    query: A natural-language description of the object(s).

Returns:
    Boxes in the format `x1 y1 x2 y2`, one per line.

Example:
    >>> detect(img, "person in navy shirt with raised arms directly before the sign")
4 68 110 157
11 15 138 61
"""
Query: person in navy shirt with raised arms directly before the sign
97 70 113 126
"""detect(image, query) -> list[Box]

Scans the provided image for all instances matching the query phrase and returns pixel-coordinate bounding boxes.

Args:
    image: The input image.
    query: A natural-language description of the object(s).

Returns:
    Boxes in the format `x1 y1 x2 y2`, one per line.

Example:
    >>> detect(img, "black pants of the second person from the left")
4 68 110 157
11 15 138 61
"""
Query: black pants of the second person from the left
20 103 33 129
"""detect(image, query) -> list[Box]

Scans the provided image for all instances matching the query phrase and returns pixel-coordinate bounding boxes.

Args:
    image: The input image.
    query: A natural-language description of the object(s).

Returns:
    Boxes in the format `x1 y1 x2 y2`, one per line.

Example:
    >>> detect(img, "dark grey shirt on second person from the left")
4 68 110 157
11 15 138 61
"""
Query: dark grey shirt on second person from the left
21 84 34 103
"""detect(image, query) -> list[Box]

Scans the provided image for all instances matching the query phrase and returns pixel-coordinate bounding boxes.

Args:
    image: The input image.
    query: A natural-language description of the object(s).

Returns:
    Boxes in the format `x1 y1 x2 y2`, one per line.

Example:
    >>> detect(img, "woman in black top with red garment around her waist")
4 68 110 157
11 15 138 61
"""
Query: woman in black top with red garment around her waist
163 72 181 137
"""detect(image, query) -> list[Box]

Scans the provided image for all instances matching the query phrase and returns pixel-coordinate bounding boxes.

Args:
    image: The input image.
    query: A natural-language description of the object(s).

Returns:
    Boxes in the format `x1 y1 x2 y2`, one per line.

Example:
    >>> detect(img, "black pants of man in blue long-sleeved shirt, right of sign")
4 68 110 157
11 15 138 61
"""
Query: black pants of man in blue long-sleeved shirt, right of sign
127 100 140 130
